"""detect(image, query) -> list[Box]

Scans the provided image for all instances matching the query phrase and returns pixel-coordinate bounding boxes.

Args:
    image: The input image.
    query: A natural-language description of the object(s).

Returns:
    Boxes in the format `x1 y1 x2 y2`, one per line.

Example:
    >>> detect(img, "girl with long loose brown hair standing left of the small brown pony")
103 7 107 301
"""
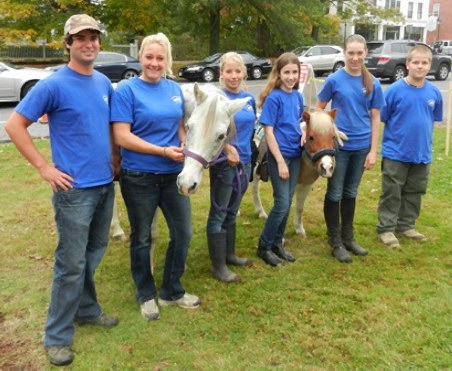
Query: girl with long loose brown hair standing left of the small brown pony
257 53 303 266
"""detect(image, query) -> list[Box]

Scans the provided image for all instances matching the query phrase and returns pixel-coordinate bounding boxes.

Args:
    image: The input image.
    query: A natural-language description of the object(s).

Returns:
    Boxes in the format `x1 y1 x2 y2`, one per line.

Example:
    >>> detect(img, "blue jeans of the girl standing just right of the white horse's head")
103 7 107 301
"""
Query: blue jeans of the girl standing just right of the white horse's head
207 164 251 234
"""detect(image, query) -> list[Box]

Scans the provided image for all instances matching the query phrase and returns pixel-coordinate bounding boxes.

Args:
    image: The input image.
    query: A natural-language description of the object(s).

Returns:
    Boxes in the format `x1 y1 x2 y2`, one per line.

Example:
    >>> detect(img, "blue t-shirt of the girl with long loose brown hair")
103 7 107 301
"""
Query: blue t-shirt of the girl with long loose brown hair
259 89 303 158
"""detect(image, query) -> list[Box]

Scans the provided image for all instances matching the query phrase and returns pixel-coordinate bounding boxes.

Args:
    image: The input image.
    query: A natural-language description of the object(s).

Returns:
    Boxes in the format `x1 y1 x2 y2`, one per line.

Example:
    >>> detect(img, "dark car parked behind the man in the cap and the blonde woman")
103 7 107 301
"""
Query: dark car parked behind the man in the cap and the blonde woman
47 52 141 82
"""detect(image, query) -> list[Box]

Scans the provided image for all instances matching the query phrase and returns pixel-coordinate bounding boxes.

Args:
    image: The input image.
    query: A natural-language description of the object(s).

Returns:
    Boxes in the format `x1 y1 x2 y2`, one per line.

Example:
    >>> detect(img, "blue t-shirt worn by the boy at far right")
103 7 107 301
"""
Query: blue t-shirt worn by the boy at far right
381 80 443 164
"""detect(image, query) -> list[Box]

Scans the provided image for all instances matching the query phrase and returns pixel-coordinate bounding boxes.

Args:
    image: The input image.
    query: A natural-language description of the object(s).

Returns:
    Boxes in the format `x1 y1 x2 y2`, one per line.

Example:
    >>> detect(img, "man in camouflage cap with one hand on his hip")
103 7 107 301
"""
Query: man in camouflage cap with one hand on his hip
5 14 118 366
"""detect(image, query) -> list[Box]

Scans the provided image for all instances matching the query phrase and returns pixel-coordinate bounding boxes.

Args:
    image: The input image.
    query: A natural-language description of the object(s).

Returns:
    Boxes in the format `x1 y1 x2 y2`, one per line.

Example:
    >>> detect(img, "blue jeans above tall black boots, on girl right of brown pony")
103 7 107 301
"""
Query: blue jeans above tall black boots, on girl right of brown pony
326 148 369 202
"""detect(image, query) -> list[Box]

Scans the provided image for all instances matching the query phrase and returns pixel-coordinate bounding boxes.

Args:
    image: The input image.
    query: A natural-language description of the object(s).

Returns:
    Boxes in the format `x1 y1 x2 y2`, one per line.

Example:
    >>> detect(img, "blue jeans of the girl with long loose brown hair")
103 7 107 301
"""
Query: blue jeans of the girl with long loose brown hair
260 151 301 249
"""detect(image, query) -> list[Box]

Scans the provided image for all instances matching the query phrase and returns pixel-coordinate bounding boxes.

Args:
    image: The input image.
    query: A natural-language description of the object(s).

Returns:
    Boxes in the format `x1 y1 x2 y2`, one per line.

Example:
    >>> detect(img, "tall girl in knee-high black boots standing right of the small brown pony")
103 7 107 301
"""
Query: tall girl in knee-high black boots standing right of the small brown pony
316 35 384 263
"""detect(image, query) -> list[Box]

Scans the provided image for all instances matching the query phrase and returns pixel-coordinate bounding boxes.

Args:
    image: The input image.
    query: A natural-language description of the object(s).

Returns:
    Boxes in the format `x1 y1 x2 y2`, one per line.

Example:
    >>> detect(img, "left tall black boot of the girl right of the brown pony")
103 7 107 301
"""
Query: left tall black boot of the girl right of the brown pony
323 197 352 263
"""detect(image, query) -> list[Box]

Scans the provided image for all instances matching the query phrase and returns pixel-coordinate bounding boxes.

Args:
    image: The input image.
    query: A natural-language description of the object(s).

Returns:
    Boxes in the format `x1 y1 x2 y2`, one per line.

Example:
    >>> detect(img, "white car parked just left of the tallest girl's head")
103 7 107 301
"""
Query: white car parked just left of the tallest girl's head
293 45 345 76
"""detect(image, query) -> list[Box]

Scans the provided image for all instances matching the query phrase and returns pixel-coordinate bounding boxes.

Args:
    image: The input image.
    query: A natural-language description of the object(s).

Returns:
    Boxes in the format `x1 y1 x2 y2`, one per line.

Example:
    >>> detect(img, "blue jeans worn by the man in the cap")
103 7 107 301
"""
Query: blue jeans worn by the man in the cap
44 183 115 347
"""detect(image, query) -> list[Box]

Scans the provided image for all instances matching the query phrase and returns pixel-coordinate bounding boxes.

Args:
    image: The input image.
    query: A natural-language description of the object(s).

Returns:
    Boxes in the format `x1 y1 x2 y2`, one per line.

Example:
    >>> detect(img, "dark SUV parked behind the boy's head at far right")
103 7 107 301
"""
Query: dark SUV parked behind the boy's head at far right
365 40 452 81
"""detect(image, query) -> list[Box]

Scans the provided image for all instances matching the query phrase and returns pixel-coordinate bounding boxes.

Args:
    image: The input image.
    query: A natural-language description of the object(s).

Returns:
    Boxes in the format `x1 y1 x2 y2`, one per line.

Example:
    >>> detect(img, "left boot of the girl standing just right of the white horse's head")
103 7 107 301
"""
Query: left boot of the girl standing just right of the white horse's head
207 232 240 282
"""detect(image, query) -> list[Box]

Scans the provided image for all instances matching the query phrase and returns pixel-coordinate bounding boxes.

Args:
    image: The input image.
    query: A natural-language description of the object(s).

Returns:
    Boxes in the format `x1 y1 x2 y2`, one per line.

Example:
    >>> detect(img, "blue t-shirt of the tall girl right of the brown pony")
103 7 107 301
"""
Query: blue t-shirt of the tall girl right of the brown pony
318 68 385 151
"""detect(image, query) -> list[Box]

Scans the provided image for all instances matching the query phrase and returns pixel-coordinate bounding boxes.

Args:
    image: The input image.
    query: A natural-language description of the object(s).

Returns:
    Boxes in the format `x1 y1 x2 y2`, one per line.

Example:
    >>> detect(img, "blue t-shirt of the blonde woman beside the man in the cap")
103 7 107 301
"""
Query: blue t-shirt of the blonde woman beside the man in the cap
111 77 184 174
